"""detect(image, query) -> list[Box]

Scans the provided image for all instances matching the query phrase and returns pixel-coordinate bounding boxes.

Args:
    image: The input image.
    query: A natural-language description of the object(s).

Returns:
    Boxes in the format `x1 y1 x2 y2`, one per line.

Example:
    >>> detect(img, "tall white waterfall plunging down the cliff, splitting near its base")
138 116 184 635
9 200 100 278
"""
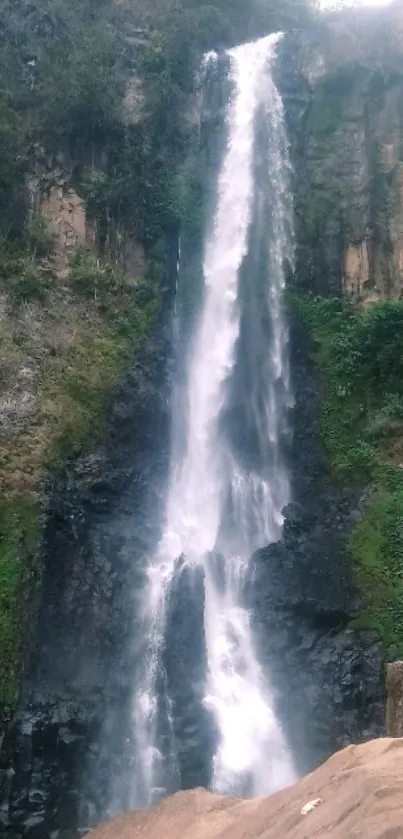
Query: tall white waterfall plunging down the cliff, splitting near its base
133 31 294 803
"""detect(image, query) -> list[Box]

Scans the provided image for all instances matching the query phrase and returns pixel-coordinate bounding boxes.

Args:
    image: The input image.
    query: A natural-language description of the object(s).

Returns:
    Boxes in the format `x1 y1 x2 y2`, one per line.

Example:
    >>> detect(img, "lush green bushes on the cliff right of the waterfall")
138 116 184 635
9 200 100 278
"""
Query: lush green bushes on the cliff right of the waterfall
294 295 403 657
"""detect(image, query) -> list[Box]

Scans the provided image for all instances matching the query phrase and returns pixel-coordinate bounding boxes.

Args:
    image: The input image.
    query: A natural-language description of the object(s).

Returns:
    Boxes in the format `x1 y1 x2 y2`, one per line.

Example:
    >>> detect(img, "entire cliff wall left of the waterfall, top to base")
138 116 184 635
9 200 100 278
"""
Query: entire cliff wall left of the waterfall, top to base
0 0 183 837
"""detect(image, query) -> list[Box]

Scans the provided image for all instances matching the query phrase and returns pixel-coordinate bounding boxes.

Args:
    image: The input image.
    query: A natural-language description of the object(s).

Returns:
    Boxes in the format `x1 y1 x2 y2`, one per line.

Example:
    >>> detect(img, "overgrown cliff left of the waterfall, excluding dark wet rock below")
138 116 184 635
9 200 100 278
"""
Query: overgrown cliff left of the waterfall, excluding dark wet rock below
0 0 192 728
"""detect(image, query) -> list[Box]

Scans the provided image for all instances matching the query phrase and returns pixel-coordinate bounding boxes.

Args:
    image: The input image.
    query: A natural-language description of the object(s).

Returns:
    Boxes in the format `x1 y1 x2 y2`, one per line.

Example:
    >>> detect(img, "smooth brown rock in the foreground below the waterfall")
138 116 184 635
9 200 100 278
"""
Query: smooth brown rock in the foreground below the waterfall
90 738 403 839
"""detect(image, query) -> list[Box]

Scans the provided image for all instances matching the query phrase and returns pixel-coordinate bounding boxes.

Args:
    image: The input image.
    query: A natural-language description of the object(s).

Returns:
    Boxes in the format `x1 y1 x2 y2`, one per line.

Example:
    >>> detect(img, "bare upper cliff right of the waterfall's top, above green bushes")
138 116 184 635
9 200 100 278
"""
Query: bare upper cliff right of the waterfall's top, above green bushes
280 3 403 300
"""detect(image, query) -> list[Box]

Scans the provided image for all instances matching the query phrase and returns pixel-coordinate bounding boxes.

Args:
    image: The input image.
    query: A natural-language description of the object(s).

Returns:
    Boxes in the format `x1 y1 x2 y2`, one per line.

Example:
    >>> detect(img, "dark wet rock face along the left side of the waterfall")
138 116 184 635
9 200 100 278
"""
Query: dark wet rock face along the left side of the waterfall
0 242 177 839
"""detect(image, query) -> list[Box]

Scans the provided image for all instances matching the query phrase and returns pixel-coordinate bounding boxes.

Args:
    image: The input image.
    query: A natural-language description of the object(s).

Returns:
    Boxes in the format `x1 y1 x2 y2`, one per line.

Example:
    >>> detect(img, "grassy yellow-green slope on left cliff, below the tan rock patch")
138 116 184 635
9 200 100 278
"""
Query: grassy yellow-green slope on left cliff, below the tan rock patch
0 241 160 480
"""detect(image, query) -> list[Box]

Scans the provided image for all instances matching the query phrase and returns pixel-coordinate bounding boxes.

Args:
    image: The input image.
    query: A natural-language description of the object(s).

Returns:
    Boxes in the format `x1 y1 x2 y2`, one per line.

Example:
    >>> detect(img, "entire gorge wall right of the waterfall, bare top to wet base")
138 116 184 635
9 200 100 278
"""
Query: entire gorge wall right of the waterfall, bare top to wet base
251 4 403 770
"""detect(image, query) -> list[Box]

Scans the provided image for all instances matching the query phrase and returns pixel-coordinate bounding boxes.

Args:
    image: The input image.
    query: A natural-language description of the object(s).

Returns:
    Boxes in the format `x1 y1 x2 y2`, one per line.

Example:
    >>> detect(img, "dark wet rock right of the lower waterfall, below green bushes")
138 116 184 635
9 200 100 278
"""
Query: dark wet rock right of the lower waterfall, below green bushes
248 323 385 772
